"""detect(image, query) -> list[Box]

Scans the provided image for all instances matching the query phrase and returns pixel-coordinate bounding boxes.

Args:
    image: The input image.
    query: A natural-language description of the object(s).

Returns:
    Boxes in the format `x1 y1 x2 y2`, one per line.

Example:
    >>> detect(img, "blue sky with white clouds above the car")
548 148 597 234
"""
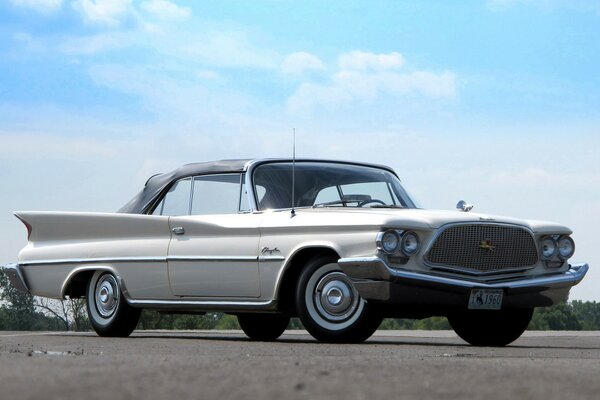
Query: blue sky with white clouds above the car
0 0 600 301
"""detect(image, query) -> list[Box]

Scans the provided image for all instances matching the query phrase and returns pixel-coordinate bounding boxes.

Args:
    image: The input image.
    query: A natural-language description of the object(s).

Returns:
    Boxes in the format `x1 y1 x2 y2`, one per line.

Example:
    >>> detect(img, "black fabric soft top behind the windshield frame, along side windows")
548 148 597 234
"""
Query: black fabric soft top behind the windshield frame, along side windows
117 160 251 214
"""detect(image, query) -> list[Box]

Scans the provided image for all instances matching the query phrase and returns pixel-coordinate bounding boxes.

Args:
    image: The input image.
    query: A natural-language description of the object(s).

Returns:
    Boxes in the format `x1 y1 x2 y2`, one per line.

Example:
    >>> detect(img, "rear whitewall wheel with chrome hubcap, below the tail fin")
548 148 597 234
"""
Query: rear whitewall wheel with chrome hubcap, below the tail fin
86 271 142 337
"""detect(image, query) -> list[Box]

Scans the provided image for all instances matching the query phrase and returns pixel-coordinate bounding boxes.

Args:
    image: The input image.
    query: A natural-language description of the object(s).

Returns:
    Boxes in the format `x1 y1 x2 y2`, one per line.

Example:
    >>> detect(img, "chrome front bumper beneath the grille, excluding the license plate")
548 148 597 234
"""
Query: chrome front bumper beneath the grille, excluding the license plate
338 257 589 306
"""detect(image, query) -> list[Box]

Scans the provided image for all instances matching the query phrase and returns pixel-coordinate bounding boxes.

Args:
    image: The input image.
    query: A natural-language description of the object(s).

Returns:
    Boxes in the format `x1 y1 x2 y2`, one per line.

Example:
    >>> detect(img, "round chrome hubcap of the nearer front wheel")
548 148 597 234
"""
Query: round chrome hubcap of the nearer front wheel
314 272 359 322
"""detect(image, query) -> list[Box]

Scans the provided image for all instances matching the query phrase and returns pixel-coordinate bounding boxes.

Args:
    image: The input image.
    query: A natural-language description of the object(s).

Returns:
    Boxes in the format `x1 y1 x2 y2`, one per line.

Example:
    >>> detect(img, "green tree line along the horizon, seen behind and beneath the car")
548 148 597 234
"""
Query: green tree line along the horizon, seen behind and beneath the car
0 269 600 331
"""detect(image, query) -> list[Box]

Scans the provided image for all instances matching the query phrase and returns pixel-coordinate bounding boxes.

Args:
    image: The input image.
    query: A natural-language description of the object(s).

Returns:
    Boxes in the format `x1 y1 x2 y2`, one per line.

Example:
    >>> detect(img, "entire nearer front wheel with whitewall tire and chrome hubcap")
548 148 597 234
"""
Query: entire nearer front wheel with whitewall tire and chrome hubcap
296 257 382 343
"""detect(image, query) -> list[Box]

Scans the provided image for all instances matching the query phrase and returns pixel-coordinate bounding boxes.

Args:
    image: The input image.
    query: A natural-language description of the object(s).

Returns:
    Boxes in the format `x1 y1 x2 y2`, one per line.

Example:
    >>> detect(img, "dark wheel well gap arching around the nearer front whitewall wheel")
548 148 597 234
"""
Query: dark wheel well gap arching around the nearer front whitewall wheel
277 247 340 316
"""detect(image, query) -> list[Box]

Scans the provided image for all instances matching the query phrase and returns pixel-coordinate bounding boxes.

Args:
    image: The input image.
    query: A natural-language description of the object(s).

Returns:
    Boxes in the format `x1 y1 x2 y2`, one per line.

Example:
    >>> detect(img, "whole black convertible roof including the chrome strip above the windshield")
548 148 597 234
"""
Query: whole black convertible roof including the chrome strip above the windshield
118 158 393 214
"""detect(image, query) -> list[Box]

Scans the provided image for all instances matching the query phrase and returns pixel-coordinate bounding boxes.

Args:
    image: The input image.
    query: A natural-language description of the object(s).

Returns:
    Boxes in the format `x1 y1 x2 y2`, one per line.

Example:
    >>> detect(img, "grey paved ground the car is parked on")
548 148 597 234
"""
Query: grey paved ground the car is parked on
0 331 600 400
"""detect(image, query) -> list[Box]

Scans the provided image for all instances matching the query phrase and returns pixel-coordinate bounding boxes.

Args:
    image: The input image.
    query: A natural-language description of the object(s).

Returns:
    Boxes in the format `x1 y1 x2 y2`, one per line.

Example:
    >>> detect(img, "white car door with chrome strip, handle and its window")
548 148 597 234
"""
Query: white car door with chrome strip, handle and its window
168 174 261 298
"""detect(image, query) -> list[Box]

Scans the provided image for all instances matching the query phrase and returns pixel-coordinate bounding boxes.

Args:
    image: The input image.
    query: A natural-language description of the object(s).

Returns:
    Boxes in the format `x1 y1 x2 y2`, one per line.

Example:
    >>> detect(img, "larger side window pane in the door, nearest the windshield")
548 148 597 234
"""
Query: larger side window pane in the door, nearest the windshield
192 174 241 215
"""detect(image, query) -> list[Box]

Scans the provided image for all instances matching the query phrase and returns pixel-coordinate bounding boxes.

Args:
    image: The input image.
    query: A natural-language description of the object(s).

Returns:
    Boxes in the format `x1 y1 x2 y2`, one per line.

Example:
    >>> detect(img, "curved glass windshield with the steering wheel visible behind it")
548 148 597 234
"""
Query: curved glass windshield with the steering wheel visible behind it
252 162 415 210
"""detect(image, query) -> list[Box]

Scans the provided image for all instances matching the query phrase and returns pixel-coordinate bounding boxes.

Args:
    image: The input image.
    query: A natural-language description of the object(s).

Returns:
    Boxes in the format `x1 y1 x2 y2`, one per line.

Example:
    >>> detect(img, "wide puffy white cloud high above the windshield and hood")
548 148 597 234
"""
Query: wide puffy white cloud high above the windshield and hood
287 51 456 113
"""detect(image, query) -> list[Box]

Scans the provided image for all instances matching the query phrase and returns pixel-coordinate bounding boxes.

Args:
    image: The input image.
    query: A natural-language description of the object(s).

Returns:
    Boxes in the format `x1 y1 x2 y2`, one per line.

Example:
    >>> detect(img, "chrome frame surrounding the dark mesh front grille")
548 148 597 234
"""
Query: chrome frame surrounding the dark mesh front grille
423 221 540 276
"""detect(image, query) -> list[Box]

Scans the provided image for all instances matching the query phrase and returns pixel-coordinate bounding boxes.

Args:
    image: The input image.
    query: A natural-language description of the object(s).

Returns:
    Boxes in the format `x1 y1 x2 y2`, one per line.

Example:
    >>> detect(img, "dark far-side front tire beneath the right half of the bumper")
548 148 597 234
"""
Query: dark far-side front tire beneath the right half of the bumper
448 308 533 347
